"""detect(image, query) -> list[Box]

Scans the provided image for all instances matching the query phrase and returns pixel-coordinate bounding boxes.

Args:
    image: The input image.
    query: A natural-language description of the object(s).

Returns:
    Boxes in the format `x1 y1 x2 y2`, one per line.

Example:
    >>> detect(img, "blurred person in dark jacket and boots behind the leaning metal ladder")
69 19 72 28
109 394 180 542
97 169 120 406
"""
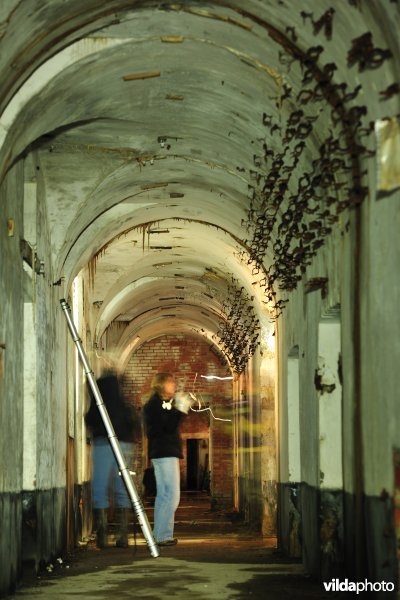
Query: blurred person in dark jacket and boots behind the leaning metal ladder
85 370 138 548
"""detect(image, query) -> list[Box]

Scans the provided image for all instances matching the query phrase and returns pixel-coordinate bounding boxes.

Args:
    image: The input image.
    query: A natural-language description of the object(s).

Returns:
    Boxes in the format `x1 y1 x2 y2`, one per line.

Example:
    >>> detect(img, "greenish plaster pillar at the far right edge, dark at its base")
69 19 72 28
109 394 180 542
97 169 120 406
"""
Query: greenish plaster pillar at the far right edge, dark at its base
360 168 400 579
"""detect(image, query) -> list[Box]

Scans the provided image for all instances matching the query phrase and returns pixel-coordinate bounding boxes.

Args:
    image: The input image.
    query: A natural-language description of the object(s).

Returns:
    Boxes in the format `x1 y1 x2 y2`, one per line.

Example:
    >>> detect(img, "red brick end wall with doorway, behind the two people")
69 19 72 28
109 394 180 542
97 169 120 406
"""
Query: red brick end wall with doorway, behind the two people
123 334 233 507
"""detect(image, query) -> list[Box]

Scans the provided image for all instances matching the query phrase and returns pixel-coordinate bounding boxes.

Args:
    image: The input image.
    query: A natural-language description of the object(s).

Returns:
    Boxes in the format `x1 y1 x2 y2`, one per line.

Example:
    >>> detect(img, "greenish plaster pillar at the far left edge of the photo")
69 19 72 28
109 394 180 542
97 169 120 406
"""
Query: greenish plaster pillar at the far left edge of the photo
0 163 24 594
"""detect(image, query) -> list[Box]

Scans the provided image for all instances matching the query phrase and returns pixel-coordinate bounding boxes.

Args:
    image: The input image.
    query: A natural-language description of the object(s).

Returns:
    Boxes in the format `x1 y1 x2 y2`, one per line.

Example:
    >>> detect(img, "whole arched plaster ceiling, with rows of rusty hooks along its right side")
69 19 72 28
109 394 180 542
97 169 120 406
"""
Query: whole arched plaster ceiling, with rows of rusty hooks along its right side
0 0 399 370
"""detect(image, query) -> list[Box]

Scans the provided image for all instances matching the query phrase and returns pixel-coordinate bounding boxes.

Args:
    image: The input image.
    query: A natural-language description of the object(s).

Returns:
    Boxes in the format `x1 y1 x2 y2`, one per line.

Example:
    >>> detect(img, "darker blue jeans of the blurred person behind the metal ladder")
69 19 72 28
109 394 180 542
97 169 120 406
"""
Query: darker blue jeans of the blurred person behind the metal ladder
92 437 133 508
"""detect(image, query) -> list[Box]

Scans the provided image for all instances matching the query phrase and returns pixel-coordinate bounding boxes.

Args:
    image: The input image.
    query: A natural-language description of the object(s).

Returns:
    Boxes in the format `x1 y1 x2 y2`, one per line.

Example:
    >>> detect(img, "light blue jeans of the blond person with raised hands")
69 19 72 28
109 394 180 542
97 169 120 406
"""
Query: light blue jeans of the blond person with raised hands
152 456 180 542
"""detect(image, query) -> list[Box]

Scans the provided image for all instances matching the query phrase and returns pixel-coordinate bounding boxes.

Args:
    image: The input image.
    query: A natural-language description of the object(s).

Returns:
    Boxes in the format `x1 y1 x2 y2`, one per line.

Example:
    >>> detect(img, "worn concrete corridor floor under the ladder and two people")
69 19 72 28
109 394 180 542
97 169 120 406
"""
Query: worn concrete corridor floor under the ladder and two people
13 498 350 600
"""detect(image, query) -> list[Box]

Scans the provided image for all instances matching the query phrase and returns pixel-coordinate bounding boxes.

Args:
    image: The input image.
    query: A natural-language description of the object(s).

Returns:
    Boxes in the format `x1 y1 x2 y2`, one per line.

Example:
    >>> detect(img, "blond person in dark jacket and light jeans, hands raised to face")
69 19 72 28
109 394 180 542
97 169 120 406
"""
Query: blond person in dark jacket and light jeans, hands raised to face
143 373 188 546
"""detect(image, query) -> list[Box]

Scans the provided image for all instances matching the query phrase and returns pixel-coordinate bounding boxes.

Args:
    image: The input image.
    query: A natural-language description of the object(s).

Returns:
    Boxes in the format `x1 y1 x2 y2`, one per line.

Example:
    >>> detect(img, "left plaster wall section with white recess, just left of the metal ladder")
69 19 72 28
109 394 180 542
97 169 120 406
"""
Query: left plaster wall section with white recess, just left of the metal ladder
21 157 67 569
